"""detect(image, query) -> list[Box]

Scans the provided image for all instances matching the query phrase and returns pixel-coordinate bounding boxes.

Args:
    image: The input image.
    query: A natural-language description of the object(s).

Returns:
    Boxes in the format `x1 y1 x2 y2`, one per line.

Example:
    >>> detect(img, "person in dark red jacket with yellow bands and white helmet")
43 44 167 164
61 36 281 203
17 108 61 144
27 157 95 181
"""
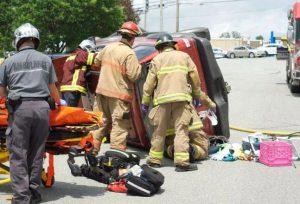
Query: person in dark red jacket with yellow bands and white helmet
60 39 96 107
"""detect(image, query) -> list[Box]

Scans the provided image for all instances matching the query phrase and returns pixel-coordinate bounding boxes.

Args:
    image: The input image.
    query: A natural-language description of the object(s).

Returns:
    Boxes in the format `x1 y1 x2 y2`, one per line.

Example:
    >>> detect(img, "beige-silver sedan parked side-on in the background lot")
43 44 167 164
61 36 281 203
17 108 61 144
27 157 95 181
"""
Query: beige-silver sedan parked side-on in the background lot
226 46 266 58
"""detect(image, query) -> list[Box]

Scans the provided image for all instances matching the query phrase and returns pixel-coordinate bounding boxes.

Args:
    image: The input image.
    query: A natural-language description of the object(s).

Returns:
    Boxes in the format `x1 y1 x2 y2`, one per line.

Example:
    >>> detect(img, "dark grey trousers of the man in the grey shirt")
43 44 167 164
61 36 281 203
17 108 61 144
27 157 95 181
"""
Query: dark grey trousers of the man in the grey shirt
6 101 49 204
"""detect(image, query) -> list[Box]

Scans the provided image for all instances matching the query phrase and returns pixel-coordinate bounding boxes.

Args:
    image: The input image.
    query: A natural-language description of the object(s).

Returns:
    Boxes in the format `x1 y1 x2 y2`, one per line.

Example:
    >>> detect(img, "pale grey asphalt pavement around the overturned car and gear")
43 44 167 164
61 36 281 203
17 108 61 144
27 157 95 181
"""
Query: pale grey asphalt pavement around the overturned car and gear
0 57 300 204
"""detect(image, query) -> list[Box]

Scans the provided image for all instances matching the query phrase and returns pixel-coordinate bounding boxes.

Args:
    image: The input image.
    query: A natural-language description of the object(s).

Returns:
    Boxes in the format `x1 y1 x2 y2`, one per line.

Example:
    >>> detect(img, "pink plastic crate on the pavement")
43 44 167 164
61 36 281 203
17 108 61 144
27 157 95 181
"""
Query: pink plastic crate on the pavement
259 141 292 166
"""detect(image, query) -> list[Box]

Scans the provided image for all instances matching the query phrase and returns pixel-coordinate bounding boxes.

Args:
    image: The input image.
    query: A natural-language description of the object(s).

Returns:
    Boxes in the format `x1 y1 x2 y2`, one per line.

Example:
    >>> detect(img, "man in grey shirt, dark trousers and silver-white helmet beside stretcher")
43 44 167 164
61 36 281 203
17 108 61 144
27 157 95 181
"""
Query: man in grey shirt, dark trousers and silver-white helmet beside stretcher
0 23 61 204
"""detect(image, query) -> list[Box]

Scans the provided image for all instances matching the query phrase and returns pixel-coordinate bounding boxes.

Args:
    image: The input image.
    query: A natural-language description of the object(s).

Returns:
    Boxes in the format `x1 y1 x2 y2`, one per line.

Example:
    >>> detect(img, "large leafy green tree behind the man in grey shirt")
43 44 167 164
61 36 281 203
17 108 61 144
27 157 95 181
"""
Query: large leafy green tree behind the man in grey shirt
0 0 125 53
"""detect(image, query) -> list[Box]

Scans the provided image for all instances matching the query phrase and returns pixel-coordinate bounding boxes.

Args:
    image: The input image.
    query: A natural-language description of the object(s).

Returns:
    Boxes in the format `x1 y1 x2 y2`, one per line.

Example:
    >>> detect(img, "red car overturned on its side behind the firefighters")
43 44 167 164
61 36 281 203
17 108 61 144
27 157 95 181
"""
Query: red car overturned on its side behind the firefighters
52 30 230 148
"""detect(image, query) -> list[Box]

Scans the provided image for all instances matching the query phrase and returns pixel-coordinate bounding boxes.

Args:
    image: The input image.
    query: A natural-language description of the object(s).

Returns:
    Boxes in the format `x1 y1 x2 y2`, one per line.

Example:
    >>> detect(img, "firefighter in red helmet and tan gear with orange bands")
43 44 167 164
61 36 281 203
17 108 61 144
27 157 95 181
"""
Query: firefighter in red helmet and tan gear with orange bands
93 22 141 154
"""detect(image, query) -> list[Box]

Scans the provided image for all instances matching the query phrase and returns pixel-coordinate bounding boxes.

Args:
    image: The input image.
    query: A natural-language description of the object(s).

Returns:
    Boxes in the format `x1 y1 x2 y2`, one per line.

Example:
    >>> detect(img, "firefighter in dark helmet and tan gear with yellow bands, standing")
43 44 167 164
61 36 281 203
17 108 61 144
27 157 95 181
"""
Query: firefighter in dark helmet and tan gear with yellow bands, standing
141 34 215 172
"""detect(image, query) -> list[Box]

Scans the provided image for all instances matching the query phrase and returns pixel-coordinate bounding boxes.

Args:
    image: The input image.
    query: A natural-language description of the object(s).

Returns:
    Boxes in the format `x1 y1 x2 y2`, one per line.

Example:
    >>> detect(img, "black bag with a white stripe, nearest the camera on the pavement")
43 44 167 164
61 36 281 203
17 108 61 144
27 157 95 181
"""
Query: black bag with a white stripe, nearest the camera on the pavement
125 176 158 197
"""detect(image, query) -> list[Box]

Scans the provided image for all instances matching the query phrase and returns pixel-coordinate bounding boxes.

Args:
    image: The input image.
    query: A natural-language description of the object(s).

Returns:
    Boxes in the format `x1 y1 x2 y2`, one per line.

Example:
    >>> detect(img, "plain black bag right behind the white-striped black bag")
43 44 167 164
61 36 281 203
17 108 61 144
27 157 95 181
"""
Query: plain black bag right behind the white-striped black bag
141 164 165 189
